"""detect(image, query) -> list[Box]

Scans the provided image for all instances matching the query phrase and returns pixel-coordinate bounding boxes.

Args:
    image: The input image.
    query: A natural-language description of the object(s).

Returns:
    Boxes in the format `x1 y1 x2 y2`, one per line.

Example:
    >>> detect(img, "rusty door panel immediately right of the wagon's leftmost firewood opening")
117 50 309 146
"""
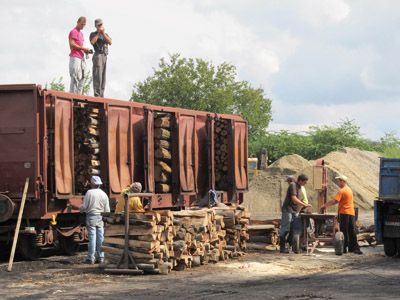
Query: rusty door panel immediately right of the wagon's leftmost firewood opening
108 106 132 194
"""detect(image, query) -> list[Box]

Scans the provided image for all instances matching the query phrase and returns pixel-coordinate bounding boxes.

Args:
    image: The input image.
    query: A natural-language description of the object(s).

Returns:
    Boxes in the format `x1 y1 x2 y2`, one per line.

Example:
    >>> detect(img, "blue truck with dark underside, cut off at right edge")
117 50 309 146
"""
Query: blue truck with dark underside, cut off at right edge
374 158 400 256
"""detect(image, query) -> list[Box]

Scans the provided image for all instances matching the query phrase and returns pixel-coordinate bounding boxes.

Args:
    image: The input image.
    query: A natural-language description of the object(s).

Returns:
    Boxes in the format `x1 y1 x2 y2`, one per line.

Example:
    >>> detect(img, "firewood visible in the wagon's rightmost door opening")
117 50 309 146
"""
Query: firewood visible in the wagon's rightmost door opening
214 119 229 190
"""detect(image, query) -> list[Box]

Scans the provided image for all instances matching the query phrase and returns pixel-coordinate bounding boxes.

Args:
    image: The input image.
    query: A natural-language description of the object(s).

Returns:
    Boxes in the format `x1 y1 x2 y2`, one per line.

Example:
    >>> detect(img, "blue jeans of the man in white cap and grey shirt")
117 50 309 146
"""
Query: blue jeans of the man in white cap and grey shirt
86 216 104 261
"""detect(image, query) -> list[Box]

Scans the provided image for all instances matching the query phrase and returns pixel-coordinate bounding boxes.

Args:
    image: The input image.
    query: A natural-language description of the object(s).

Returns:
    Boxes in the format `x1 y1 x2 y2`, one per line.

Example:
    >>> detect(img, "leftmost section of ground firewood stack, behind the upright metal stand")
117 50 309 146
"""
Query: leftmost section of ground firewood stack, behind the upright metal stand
102 211 174 273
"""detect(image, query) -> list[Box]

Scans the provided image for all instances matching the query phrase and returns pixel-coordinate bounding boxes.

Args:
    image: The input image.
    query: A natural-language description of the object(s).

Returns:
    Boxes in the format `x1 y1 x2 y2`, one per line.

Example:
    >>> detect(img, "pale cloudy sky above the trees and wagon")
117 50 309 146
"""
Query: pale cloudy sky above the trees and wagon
0 0 400 139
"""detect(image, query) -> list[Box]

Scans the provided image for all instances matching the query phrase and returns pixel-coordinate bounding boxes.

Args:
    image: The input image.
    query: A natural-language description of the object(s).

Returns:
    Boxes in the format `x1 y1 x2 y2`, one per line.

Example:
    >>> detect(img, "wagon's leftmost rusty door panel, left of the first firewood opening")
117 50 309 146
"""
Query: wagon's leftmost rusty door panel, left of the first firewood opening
54 98 73 198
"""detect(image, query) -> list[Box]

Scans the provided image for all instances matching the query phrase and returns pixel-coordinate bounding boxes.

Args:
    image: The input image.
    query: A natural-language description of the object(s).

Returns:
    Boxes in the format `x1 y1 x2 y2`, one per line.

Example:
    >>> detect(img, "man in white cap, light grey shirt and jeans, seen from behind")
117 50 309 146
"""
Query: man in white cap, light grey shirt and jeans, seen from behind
79 176 110 264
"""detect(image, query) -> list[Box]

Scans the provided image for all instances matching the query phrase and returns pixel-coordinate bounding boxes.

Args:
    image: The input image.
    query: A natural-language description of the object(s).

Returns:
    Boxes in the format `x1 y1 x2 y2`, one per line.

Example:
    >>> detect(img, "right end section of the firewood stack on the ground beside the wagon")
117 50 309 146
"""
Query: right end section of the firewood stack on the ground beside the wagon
214 206 250 256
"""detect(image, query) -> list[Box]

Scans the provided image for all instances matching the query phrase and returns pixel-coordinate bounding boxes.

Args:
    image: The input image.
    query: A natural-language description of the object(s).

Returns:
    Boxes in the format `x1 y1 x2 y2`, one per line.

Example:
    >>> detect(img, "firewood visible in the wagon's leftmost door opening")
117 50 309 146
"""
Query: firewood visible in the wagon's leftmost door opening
74 103 100 194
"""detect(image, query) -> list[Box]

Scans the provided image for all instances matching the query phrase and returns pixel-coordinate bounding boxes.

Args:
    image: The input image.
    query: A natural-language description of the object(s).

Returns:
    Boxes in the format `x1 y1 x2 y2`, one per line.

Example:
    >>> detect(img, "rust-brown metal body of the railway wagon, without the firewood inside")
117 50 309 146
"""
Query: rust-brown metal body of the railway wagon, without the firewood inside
0 84 248 255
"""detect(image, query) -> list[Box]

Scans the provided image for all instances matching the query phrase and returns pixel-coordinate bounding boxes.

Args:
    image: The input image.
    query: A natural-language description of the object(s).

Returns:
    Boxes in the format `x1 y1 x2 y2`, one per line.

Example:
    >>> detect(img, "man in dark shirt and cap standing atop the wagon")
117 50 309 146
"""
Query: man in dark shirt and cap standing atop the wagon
89 19 112 97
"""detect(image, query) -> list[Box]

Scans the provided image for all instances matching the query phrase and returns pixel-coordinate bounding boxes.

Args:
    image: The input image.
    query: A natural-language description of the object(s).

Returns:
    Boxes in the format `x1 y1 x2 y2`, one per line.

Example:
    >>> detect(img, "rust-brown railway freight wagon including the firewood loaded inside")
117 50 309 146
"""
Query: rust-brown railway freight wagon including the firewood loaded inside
0 84 248 259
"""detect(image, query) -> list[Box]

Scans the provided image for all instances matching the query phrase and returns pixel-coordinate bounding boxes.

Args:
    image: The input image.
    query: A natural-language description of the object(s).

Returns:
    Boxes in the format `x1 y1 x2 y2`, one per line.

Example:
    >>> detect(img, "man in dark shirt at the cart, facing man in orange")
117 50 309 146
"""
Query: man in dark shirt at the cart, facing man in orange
279 174 311 253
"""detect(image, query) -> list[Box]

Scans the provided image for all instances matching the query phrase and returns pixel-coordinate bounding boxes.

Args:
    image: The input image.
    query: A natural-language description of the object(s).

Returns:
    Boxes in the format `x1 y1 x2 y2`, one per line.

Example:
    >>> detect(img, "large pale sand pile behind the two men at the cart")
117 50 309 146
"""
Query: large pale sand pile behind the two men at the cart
244 148 379 219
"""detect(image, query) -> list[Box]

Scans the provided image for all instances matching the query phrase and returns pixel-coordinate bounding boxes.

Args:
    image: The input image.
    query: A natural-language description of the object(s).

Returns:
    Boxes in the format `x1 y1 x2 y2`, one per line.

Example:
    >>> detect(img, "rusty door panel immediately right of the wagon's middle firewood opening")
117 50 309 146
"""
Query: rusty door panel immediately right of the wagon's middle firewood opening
179 115 195 192
